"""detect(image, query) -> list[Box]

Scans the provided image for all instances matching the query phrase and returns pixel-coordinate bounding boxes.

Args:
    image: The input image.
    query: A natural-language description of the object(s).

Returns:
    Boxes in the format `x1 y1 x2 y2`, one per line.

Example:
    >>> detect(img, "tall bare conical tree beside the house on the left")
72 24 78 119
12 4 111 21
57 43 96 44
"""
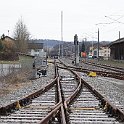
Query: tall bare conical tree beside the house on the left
14 19 30 53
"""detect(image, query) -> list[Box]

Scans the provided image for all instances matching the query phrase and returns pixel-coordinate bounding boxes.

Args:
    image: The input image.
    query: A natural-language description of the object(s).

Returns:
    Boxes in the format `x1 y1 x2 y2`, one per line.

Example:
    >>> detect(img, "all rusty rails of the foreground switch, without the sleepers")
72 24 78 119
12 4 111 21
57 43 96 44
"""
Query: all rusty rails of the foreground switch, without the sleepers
0 60 124 124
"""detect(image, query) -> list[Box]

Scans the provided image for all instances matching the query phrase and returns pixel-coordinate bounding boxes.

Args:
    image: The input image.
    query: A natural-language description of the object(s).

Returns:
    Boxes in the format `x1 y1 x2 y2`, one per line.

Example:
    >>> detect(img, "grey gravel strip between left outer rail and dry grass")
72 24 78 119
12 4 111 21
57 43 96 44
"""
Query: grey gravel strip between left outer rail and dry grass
0 64 55 107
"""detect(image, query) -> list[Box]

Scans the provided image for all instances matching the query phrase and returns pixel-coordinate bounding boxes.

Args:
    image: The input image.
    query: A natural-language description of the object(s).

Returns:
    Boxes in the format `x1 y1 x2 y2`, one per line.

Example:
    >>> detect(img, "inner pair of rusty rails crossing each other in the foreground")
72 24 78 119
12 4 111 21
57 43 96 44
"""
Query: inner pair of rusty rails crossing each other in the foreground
39 65 82 124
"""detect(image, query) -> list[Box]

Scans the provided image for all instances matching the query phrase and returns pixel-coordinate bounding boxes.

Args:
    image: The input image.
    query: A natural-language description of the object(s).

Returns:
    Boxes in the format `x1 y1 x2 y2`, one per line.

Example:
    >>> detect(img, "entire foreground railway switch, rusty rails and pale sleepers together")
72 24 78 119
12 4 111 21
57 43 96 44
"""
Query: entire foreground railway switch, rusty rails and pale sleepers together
0 61 124 124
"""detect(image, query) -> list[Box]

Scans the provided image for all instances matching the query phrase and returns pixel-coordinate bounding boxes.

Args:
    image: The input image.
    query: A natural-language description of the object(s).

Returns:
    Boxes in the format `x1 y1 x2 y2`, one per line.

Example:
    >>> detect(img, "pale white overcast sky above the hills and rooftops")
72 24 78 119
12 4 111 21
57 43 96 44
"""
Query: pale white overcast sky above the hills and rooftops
0 0 124 41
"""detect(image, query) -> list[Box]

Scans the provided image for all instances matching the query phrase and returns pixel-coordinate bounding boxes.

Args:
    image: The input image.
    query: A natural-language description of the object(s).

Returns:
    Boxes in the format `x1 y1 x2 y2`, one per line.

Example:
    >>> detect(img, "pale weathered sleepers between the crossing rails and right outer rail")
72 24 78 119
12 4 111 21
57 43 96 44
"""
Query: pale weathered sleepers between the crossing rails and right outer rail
69 87 118 124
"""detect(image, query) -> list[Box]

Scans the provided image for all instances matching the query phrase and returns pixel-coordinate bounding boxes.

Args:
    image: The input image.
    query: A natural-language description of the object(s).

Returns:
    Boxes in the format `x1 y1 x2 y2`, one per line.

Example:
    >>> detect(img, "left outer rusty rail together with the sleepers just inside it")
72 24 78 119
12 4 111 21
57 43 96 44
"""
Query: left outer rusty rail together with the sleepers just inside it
0 76 57 124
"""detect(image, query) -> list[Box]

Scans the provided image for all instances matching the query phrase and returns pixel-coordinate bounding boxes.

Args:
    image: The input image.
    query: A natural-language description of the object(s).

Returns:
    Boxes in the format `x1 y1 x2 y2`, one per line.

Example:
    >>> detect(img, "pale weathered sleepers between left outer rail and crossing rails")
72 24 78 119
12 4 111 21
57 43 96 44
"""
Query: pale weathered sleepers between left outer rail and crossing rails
0 86 56 124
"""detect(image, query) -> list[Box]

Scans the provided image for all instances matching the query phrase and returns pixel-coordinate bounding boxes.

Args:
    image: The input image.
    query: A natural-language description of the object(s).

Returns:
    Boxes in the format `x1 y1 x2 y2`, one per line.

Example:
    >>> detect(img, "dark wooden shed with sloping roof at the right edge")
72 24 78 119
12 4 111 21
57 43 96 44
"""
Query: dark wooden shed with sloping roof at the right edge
109 38 124 60
